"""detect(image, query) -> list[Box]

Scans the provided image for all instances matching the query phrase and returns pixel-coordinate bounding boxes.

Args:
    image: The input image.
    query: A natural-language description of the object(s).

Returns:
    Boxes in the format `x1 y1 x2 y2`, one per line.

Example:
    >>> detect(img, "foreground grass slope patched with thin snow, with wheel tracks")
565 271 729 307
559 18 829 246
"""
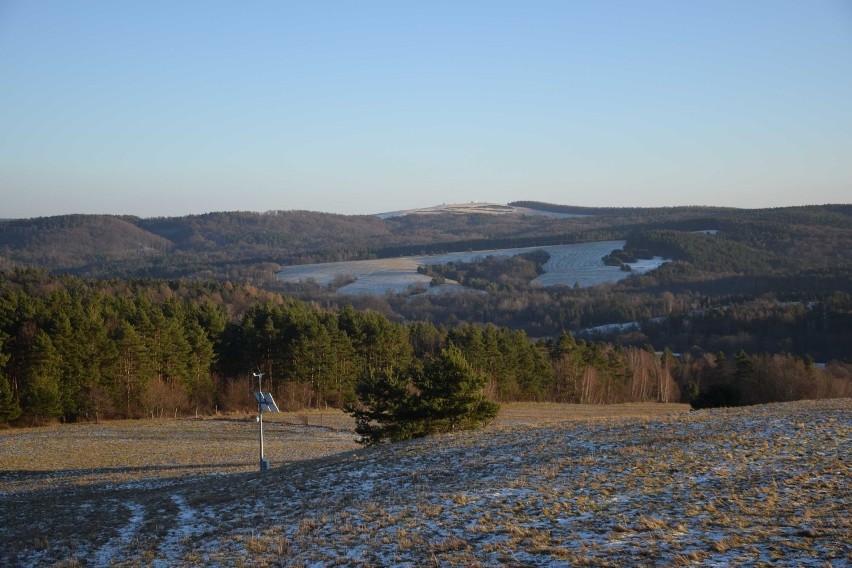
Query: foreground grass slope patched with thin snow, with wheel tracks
0 399 852 566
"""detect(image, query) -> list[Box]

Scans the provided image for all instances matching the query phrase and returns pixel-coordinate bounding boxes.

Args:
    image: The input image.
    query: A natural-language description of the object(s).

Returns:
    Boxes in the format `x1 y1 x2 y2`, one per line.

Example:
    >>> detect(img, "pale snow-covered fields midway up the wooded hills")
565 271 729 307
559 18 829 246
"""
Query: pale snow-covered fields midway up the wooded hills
278 241 665 295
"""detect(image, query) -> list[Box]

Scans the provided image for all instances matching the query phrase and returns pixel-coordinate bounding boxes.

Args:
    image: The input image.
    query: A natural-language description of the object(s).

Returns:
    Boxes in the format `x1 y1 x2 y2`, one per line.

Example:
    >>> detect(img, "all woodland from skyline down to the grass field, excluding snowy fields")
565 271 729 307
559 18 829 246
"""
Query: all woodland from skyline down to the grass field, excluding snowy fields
0 202 852 424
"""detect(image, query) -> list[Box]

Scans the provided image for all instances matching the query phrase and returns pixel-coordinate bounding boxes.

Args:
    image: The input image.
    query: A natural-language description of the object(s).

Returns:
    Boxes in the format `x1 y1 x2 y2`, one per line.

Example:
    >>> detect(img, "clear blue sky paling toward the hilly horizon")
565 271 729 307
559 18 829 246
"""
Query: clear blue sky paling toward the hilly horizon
0 0 852 218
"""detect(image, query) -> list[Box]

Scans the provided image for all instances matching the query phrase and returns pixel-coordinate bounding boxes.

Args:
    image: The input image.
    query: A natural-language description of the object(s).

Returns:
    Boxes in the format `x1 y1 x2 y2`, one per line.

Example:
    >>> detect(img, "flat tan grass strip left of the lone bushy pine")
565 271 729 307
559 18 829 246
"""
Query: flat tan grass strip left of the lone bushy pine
0 411 358 495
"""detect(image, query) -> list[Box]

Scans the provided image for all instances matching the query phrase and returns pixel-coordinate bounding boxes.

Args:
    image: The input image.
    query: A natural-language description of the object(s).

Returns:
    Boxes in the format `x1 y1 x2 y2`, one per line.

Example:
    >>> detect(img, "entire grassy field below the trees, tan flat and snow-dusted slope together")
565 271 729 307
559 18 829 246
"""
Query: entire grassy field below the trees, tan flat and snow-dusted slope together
0 400 852 566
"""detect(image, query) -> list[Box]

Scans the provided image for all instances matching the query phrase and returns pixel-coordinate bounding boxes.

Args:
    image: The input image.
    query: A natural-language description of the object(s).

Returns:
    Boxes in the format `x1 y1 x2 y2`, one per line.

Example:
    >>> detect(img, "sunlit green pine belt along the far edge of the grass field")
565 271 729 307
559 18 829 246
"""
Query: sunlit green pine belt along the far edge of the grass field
0 269 850 423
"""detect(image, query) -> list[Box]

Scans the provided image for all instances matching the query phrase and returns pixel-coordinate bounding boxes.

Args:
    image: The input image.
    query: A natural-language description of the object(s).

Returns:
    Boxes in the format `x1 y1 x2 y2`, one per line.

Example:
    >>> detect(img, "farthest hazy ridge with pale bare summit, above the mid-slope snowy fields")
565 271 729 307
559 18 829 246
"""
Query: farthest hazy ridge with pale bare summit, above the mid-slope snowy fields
0 201 852 281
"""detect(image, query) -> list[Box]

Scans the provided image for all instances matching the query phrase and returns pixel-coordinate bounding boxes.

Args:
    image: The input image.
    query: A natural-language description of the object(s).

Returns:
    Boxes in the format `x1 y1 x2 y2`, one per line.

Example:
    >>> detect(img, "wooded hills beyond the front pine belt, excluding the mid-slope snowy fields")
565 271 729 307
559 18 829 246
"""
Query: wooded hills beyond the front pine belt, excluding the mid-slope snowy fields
0 202 852 363
